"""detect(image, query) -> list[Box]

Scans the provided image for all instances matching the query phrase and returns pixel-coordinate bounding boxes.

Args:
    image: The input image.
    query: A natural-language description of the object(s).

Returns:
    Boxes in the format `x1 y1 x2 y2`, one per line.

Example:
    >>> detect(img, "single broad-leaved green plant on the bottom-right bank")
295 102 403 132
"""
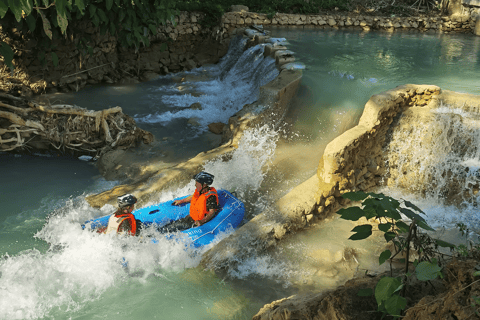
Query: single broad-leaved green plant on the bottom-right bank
337 191 454 316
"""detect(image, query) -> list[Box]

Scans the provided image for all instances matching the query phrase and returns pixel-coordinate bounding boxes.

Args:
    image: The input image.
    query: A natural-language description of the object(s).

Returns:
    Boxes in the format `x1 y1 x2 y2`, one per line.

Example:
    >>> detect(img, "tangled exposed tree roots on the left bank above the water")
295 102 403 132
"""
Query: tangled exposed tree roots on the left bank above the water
0 94 153 156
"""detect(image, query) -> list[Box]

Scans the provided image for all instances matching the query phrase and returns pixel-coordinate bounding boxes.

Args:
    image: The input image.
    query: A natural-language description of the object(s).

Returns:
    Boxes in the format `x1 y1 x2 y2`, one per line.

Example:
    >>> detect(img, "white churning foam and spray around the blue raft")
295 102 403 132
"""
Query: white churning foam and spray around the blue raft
0 127 284 319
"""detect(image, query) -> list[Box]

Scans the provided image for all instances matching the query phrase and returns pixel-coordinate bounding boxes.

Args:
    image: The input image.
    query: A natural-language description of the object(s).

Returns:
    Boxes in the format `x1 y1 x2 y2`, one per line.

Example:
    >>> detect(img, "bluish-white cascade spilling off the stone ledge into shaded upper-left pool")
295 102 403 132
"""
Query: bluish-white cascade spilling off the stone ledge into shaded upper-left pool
135 38 278 132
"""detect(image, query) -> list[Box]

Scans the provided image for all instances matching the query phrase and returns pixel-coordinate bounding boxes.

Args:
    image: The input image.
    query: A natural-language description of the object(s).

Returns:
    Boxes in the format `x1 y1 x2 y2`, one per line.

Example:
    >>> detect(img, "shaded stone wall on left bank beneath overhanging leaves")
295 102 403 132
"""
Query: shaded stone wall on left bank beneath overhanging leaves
0 12 230 95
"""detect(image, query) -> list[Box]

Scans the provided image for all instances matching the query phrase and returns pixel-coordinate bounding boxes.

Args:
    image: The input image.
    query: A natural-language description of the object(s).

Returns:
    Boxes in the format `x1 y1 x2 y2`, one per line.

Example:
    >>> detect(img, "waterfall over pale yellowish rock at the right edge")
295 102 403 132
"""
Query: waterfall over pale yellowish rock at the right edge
386 104 480 230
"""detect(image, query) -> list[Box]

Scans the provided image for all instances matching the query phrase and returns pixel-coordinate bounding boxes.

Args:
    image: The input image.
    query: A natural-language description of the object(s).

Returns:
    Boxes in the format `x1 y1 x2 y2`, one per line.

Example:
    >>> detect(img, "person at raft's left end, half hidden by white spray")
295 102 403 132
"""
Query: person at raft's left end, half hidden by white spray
103 194 141 236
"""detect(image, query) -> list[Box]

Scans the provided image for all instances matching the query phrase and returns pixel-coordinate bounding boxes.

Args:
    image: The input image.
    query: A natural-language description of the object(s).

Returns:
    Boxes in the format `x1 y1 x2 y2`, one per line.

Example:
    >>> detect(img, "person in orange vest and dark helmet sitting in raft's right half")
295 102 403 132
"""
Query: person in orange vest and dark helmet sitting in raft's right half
160 171 219 233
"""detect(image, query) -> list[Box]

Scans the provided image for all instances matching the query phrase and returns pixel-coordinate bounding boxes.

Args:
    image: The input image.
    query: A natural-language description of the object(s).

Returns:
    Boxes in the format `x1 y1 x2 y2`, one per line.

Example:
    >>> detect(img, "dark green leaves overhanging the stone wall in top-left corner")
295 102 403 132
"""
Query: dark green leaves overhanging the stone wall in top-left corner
0 0 178 69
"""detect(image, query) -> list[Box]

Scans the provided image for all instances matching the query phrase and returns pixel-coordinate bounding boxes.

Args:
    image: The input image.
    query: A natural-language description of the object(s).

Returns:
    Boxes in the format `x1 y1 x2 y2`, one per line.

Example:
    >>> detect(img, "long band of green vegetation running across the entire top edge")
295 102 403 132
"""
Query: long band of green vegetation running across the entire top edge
0 0 448 71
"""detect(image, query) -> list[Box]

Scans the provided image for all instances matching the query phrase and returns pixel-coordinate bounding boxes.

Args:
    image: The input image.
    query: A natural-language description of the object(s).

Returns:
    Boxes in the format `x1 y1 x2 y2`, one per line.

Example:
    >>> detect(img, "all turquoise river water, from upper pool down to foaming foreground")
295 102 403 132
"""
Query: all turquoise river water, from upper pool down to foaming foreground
0 29 480 319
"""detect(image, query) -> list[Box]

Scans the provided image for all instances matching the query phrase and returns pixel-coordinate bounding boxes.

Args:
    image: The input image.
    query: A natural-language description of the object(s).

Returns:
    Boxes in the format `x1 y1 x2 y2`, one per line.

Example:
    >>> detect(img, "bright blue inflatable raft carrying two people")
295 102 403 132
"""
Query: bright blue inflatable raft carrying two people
83 190 245 247
